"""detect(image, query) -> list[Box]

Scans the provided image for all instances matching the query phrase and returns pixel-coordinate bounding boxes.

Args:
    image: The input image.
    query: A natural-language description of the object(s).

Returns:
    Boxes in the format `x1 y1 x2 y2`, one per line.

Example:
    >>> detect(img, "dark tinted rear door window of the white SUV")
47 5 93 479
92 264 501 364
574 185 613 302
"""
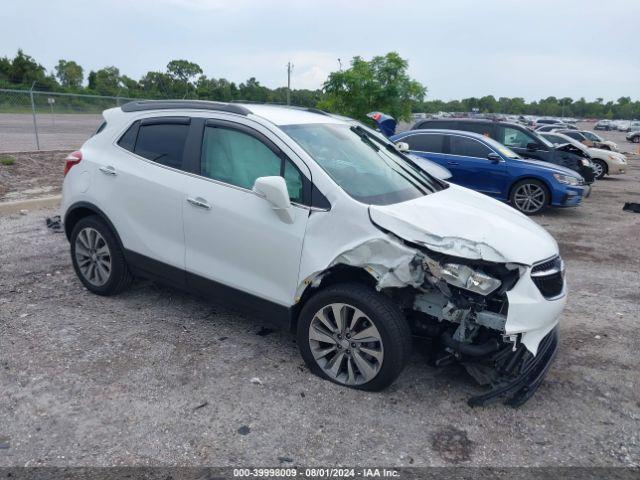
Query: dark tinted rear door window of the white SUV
134 123 189 169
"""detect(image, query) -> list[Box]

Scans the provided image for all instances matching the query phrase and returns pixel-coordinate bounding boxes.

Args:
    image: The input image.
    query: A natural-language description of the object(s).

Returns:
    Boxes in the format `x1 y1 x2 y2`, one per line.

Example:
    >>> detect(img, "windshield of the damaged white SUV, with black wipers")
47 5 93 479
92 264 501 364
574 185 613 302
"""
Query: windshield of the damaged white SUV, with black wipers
281 123 443 205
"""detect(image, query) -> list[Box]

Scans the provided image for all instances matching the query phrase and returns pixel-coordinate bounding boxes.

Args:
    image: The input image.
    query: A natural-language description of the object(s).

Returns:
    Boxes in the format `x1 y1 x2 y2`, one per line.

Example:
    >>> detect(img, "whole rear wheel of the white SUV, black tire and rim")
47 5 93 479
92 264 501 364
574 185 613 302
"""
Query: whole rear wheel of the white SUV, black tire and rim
69 215 133 296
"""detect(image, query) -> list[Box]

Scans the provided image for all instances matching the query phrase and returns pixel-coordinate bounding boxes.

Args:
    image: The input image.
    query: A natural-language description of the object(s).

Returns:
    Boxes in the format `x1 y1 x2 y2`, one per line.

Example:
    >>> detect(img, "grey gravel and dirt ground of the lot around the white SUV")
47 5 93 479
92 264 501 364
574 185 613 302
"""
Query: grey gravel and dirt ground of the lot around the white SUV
0 129 640 466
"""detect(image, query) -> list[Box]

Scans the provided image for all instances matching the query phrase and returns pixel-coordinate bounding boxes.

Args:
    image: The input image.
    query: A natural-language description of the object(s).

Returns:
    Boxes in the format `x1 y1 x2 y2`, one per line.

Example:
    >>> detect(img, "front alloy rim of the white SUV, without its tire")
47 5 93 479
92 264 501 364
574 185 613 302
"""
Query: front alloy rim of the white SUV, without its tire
309 303 384 385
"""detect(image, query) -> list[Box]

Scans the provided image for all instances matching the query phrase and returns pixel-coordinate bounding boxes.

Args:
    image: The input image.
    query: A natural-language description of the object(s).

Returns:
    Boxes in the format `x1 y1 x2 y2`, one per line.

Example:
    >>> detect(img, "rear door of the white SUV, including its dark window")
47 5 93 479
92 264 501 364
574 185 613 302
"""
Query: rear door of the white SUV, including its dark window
92 117 190 283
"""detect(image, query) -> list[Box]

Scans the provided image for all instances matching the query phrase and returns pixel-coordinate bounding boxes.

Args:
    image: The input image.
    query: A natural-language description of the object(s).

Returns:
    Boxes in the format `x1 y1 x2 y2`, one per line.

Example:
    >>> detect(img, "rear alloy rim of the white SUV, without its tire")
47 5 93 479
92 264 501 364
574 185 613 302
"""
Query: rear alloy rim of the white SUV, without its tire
75 227 111 287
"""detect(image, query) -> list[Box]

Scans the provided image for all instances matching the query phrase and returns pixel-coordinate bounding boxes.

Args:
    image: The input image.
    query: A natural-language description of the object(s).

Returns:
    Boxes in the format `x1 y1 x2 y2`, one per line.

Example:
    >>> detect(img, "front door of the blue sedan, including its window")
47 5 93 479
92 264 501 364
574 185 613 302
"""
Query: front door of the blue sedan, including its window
447 134 508 197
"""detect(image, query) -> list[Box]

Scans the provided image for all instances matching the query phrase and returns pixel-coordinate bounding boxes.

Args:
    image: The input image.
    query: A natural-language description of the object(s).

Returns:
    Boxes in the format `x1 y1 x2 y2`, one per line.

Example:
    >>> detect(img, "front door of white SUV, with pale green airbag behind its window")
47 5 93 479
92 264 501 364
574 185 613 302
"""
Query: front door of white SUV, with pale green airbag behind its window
183 120 310 317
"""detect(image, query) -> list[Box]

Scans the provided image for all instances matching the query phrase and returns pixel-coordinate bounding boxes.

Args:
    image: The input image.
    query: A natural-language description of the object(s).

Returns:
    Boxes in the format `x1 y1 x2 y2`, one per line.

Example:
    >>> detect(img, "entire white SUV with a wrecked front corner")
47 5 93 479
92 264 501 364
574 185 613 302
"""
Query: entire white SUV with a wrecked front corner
61 101 566 405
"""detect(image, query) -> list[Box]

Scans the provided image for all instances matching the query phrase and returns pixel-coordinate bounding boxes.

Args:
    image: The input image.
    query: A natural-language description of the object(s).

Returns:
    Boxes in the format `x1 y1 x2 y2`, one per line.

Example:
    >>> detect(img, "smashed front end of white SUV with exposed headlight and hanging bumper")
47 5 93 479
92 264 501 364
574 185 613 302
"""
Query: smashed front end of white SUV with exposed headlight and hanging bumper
310 233 565 406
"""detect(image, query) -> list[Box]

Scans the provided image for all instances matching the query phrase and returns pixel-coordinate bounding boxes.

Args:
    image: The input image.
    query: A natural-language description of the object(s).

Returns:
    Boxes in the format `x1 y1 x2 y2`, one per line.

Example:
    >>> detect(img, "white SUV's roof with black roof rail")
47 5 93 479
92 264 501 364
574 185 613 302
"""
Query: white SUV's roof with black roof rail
121 100 345 125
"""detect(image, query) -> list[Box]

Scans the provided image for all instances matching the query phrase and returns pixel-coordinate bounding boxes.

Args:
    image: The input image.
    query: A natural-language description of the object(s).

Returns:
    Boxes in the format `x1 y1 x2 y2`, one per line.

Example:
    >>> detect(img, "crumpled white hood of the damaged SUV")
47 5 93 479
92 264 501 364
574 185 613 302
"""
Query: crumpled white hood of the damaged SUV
369 184 558 265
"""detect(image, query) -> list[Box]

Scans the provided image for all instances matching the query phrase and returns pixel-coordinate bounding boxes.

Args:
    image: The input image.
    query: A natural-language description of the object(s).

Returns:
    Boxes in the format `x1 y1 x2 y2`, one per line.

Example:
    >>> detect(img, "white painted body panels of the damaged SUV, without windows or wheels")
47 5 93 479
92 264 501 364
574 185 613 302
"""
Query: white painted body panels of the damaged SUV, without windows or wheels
61 105 566 354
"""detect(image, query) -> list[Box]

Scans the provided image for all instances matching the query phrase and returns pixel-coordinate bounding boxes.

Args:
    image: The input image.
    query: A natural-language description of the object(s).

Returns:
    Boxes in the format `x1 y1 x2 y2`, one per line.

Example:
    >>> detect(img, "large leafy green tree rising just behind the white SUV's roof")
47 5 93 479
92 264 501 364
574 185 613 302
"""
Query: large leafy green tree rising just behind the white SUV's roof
319 52 426 121
